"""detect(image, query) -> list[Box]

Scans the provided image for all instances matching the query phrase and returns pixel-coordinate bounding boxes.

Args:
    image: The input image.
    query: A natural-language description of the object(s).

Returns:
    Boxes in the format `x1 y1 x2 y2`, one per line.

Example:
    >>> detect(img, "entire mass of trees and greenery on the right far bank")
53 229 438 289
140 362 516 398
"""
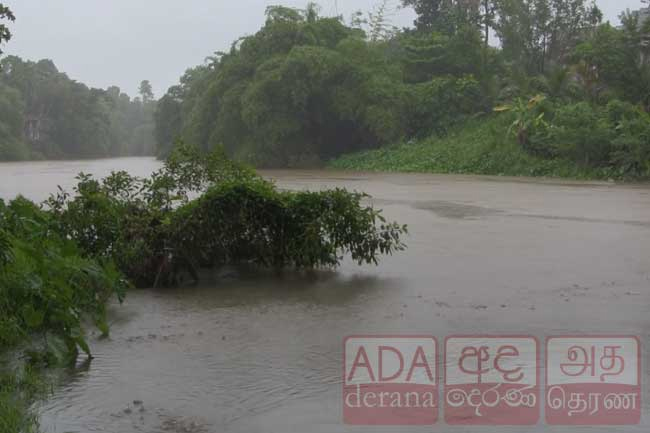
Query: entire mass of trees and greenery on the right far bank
156 0 650 178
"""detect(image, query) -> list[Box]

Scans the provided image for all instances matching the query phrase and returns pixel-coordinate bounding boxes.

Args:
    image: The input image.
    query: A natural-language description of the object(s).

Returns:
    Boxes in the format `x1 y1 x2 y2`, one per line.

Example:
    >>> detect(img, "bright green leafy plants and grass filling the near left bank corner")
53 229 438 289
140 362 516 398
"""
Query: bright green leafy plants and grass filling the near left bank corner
0 198 127 433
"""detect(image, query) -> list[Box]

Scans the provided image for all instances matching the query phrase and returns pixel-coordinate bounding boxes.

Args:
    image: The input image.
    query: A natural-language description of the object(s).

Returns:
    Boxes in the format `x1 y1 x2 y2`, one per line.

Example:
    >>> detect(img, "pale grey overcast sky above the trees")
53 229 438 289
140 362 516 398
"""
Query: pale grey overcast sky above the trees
0 0 641 96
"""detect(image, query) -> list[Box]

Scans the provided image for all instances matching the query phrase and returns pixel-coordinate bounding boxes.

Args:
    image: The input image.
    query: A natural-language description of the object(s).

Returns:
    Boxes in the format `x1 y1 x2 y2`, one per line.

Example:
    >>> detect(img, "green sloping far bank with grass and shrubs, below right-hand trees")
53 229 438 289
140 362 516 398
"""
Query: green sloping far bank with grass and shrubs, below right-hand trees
329 105 650 179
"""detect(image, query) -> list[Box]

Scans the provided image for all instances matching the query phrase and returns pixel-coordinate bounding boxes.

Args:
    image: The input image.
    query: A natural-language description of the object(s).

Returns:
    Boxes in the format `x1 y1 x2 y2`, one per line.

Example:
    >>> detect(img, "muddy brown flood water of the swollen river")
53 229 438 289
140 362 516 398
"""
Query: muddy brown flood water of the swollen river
0 158 650 433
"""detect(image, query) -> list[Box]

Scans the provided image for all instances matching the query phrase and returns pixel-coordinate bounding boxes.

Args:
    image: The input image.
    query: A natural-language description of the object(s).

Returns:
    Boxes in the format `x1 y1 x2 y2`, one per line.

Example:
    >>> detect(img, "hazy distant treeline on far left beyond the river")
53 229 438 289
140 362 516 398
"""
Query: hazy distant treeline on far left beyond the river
0 56 156 161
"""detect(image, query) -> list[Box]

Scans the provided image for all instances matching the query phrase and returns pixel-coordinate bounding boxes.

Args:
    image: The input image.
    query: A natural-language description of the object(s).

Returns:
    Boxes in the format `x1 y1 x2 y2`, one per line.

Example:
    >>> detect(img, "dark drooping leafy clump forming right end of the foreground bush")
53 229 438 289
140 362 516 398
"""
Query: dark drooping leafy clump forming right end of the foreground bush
170 179 406 269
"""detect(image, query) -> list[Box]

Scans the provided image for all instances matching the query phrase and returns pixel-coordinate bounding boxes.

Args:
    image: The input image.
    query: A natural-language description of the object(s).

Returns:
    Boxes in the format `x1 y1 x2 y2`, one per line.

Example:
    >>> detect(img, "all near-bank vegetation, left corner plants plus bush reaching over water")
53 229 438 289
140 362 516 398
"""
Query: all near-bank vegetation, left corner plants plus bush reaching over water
0 144 406 433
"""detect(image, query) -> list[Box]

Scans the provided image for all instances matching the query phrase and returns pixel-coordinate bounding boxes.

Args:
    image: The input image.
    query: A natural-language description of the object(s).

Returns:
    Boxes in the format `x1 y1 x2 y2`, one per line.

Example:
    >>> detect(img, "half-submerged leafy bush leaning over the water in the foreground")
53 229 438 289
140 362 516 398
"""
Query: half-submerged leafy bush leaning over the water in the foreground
48 140 405 286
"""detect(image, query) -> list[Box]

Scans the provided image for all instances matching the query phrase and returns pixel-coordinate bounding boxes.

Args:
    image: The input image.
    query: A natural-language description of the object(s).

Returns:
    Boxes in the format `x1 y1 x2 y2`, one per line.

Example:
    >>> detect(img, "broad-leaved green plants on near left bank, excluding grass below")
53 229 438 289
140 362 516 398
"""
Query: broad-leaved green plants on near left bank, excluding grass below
0 197 127 360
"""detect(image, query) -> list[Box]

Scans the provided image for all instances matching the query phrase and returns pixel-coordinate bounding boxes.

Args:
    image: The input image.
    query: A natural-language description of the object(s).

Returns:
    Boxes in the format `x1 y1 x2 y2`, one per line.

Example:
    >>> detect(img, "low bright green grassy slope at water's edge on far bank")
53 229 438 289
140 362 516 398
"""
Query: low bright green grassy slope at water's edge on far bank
329 117 610 179
